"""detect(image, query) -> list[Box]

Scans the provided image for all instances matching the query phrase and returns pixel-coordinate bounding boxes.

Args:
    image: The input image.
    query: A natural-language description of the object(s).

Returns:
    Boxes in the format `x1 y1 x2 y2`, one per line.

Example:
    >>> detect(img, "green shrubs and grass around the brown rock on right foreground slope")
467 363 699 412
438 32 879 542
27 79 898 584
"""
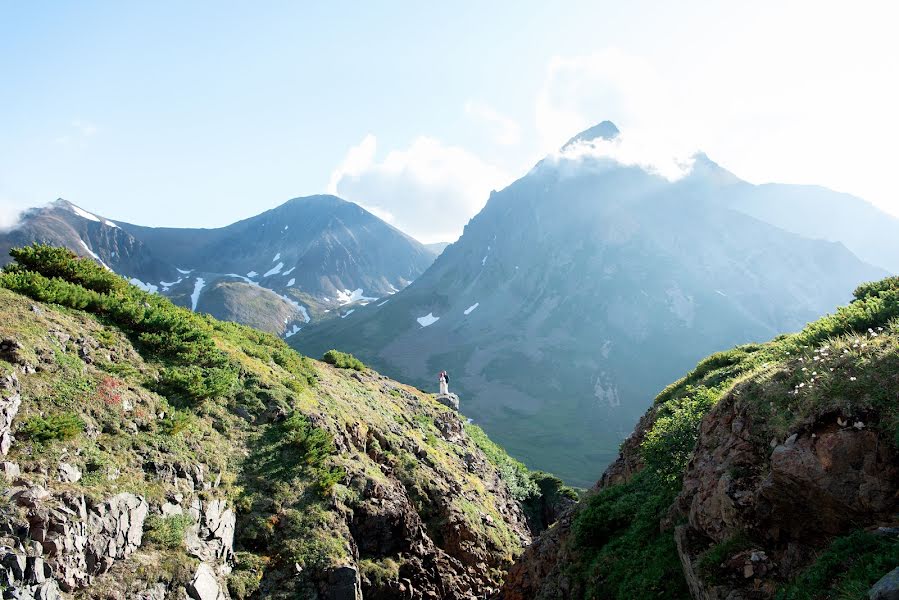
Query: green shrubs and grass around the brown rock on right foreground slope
566 278 899 599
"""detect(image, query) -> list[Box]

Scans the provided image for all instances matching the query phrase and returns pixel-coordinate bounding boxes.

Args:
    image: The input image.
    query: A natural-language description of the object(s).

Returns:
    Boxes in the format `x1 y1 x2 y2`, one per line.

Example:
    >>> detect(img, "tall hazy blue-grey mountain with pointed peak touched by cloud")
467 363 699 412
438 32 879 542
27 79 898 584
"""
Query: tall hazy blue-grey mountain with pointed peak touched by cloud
292 122 899 486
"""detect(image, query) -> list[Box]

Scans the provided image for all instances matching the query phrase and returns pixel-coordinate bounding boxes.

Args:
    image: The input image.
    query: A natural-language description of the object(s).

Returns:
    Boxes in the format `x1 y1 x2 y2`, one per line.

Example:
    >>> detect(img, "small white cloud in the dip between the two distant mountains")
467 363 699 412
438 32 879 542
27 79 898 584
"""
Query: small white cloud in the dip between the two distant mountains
328 135 511 243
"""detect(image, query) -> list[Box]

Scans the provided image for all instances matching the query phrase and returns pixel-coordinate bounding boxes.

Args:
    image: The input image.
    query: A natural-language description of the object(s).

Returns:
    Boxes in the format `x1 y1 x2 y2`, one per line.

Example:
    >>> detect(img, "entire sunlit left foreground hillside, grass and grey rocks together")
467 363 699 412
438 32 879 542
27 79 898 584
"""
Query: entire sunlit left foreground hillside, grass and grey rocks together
0 247 573 600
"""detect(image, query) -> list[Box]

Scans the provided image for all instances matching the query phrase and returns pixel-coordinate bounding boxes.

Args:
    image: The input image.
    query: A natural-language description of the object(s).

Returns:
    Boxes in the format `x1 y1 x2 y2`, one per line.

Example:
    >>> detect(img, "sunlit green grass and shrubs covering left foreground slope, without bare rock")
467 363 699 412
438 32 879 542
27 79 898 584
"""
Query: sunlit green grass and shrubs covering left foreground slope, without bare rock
0 246 572 597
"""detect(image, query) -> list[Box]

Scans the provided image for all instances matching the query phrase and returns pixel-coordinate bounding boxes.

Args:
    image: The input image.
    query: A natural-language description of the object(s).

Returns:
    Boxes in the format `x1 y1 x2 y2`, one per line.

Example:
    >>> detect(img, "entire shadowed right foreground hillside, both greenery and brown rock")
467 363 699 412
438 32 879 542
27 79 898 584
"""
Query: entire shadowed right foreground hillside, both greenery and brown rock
499 278 899 600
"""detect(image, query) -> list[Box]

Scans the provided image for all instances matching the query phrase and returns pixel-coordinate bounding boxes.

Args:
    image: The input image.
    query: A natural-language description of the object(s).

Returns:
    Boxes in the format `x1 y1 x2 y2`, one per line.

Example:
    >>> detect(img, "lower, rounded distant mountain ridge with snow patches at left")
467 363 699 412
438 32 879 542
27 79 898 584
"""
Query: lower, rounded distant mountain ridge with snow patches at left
0 196 434 335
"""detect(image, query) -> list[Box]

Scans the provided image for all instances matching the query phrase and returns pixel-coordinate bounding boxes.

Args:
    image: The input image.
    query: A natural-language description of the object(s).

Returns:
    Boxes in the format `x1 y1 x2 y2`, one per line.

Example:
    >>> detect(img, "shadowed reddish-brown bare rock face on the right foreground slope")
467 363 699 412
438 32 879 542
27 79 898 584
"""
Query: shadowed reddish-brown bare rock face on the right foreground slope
677 394 899 598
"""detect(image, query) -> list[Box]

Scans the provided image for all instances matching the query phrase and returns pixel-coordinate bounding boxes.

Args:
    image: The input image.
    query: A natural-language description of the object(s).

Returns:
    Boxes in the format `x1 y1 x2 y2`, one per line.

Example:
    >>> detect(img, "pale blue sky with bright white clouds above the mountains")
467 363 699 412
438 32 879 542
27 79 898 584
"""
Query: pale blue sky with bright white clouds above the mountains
0 0 899 242
